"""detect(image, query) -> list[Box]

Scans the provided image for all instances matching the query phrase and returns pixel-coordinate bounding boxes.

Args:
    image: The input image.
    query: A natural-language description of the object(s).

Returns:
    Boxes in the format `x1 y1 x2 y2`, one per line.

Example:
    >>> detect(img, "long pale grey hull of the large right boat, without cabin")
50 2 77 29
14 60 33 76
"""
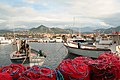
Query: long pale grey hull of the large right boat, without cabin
64 43 111 58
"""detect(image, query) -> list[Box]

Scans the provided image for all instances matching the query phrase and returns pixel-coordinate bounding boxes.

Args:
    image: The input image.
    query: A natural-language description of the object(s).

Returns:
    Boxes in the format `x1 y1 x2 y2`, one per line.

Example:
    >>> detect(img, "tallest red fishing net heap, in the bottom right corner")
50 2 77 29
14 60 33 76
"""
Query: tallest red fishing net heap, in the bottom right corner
91 53 120 80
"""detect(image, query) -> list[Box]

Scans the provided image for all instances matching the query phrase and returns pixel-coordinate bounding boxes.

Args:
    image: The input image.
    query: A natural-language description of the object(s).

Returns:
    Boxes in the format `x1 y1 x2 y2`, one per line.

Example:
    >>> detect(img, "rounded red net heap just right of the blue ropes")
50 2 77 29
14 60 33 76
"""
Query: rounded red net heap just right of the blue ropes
57 59 89 80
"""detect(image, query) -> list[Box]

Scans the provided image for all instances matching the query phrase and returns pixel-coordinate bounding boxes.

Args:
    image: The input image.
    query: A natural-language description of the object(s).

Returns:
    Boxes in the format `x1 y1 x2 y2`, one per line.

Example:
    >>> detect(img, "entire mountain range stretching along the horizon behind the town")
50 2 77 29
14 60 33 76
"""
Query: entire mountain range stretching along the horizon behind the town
0 25 120 34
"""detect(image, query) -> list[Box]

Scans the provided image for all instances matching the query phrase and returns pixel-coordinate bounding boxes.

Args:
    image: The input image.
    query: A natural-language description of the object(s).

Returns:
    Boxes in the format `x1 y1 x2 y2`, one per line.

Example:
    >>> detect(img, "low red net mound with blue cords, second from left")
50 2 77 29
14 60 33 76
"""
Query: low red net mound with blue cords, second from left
19 66 56 80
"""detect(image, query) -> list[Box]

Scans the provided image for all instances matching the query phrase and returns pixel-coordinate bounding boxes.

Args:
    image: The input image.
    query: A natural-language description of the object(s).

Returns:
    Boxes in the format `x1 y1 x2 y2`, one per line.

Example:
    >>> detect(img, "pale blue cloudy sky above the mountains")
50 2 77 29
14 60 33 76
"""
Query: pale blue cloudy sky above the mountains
0 0 120 29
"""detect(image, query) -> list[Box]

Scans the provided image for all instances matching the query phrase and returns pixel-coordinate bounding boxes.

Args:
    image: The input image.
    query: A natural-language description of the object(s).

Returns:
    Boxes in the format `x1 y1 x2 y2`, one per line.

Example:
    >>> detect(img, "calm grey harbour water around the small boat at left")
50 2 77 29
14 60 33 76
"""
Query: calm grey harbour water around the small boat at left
0 42 74 68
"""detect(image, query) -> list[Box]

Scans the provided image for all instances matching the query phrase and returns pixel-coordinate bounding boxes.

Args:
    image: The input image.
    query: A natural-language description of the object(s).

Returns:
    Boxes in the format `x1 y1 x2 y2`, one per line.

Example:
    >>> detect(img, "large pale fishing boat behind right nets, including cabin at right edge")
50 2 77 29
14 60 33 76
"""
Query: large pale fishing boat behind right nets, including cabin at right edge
64 34 120 58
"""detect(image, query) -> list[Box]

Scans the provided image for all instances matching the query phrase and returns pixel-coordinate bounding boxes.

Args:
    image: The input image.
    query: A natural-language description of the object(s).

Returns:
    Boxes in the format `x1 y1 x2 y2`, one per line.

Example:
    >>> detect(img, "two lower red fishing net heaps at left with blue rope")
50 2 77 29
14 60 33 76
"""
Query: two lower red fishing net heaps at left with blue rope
0 64 63 80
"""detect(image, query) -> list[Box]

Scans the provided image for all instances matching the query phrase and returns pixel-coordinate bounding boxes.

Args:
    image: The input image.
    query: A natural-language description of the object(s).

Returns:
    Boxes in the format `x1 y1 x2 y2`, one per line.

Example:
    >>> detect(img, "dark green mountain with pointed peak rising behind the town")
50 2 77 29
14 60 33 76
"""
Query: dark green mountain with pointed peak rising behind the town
30 25 71 34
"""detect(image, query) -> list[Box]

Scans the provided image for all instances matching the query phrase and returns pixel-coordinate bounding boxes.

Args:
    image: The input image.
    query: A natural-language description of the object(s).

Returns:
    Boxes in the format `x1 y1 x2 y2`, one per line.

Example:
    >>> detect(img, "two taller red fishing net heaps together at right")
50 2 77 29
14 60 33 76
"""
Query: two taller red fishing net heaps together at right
57 52 120 80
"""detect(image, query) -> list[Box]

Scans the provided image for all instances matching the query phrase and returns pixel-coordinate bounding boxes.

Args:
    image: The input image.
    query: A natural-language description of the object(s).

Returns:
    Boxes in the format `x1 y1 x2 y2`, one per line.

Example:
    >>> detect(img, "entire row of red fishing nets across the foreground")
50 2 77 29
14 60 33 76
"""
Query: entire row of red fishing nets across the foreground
0 52 120 80
